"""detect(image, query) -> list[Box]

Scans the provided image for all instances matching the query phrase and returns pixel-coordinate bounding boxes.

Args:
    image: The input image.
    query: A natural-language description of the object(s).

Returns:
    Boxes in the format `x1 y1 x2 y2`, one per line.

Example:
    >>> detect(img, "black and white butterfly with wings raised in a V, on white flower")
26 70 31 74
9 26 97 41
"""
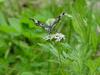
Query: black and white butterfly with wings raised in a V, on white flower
29 12 65 34
